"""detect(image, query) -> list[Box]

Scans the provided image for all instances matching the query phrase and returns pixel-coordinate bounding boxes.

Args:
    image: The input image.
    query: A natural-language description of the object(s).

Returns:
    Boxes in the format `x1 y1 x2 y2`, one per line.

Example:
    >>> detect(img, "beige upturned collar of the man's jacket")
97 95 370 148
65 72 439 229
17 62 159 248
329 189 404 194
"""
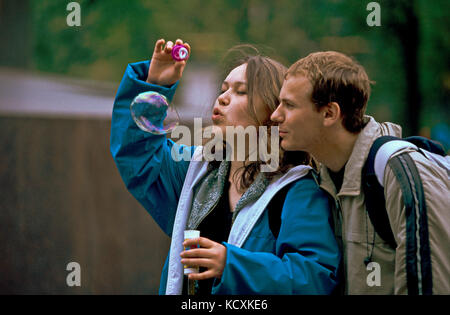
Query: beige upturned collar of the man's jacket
320 116 402 196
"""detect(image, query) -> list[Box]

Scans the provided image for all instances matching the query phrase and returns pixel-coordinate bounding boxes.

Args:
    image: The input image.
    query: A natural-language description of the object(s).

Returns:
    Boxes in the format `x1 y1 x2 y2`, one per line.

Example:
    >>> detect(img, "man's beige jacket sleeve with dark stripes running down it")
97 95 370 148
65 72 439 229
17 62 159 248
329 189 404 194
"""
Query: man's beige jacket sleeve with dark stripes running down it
384 152 450 295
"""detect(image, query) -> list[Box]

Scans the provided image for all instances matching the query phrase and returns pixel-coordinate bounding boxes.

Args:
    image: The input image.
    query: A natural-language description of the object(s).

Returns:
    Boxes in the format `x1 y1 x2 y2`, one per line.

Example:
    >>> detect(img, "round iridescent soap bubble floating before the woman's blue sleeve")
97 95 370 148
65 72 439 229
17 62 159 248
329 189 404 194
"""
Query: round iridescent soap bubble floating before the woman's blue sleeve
130 91 180 135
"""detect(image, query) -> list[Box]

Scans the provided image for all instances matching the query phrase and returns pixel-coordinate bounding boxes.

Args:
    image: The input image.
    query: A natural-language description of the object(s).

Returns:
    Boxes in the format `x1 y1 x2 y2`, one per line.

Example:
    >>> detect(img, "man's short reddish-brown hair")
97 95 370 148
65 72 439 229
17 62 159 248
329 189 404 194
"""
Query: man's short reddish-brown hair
286 51 372 133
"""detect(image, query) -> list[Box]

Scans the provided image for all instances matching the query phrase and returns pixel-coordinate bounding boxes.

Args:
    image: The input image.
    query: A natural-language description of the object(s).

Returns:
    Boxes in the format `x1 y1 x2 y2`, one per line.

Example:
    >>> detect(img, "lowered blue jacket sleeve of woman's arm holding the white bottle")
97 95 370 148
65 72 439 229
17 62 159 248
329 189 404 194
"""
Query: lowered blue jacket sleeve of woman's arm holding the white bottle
213 178 340 294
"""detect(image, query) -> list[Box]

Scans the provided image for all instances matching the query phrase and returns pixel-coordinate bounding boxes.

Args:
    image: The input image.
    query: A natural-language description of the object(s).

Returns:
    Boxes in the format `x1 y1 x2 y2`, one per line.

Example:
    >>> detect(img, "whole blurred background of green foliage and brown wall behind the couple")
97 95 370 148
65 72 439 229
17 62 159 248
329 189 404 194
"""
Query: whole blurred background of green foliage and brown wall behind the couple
0 0 450 294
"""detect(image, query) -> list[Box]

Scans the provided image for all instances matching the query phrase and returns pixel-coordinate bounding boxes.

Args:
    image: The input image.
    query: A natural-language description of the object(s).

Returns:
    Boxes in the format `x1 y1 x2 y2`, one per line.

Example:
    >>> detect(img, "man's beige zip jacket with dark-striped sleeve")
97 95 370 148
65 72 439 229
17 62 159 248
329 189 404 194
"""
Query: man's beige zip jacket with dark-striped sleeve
320 116 450 294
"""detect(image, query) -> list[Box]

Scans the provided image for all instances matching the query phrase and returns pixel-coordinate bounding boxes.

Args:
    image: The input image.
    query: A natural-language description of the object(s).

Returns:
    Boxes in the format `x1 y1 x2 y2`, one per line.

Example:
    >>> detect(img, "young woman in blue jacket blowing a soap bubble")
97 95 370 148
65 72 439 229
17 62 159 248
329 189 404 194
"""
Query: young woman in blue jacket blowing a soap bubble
111 39 340 294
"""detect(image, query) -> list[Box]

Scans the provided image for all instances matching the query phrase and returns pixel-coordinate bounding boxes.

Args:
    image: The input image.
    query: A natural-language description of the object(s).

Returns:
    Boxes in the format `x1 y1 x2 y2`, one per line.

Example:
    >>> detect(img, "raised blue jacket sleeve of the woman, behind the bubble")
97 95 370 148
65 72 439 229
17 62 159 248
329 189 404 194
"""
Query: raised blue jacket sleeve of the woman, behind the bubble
110 61 195 236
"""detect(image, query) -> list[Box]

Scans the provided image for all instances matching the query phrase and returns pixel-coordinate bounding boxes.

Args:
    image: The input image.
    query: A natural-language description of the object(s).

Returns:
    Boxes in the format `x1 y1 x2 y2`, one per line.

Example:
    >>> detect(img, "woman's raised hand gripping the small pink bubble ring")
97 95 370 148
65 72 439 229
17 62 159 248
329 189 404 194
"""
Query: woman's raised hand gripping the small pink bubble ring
147 39 191 85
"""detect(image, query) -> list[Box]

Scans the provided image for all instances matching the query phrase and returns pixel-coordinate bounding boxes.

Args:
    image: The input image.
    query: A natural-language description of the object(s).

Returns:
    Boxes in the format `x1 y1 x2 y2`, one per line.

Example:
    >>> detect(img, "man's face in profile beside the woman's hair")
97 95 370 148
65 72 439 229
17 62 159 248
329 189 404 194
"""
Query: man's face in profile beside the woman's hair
270 75 323 153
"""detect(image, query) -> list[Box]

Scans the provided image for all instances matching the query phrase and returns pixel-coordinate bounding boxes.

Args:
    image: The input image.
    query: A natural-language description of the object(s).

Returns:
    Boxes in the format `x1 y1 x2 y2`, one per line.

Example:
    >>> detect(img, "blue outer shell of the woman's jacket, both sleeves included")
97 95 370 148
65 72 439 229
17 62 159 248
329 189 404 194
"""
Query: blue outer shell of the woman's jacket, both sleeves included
111 61 340 294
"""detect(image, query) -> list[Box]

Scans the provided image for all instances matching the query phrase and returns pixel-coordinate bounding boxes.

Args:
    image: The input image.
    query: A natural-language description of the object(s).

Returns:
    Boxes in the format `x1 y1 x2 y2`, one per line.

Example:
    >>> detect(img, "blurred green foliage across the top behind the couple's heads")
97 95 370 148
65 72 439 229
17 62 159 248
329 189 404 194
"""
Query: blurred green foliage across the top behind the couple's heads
31 0 450 133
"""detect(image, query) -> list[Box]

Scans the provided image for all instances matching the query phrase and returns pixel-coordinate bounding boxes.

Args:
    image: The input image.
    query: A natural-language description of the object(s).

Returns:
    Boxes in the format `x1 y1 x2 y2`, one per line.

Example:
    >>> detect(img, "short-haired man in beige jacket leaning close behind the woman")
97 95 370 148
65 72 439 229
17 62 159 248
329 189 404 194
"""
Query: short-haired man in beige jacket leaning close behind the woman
271 51 450 295
